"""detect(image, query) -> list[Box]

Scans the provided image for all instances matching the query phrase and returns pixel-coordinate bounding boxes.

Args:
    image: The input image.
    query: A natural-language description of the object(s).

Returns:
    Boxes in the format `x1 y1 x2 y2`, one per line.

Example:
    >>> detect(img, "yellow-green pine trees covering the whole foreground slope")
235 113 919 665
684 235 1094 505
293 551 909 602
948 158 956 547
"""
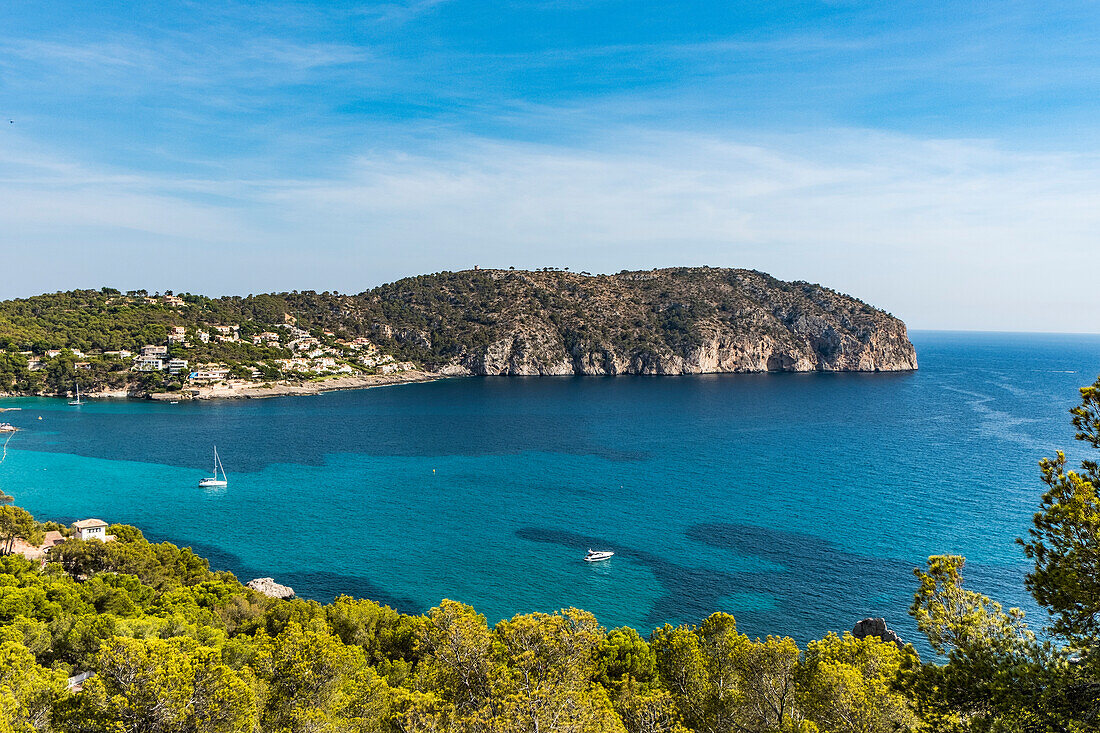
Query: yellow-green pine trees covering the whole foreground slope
0 381 1100 733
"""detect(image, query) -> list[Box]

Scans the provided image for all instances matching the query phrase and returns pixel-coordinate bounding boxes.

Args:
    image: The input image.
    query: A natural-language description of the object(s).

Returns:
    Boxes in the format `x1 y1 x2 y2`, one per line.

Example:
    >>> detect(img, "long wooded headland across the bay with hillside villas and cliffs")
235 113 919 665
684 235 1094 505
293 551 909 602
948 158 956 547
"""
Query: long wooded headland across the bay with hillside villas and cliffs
0 267 916 394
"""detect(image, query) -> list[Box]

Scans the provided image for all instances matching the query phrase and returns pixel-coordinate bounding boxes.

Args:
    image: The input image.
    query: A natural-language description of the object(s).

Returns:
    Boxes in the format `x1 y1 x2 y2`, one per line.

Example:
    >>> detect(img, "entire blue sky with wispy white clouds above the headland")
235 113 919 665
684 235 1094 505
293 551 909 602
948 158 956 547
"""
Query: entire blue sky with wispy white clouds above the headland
0 0 1100 331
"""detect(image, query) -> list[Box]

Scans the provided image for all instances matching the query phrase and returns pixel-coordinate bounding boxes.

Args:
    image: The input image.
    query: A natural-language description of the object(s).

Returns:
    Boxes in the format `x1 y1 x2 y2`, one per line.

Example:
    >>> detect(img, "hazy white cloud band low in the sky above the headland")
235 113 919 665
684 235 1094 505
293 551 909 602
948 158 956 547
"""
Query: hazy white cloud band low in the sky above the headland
0 130 1100 330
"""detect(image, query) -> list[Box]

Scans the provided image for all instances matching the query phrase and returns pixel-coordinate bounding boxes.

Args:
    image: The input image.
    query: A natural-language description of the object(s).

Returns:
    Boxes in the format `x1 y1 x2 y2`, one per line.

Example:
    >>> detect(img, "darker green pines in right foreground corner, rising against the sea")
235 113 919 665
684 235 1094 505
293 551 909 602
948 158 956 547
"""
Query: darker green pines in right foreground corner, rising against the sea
901 380 1100 732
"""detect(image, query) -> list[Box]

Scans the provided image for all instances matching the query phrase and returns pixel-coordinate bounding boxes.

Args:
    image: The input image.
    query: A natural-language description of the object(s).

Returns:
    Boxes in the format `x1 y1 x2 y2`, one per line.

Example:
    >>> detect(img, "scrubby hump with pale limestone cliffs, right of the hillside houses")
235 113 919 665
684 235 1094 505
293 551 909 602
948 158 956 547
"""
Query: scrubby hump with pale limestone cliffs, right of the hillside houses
358 267 916 375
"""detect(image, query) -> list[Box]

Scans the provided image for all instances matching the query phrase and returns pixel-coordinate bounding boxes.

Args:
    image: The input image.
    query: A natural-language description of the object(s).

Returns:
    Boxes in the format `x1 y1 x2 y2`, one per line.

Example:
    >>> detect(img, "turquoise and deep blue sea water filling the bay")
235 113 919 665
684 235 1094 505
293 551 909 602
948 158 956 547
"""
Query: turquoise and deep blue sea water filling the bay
0 332 1100 641
